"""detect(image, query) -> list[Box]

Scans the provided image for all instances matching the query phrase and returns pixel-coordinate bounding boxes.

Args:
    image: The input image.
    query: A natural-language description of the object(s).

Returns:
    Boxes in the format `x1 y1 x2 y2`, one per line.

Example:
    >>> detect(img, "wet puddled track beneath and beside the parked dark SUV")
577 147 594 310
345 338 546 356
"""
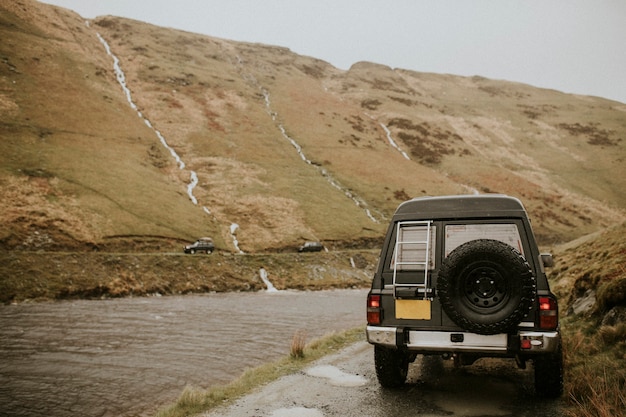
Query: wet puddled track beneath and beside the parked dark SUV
206 342 561 417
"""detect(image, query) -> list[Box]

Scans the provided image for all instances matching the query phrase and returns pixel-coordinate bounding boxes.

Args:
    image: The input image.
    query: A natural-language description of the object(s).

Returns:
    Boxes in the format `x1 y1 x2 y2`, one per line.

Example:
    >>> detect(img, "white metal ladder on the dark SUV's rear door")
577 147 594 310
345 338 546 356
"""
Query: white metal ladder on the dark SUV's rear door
393 220 432 299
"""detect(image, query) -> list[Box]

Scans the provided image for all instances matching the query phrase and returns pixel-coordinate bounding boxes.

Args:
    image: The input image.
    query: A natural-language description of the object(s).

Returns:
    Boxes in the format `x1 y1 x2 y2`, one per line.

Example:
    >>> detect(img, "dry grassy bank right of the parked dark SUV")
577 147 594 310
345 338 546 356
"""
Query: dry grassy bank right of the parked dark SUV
550 224 626 417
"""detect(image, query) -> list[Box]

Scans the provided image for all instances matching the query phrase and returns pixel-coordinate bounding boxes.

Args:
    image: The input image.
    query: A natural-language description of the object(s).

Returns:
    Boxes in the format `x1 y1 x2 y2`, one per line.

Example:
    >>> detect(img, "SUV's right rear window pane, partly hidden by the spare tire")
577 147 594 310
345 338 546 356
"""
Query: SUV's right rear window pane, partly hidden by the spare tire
445 223 524 257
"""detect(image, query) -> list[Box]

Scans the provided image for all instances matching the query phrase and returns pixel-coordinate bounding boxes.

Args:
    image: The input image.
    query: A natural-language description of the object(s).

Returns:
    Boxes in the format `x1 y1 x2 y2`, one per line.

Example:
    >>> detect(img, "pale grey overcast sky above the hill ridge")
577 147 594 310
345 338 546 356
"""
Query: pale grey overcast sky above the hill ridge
44 0 626 103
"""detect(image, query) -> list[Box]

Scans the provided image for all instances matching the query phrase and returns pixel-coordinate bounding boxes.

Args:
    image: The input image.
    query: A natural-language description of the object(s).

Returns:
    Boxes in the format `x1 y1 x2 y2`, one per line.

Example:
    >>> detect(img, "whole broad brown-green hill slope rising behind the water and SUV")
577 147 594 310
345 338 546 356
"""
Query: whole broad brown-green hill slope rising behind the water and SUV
0 0 626 252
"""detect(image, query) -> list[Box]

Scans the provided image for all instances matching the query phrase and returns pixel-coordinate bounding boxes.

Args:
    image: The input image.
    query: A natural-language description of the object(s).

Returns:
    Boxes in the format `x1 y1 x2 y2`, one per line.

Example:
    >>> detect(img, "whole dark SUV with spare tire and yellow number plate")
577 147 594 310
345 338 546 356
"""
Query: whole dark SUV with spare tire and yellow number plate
366 195 563 397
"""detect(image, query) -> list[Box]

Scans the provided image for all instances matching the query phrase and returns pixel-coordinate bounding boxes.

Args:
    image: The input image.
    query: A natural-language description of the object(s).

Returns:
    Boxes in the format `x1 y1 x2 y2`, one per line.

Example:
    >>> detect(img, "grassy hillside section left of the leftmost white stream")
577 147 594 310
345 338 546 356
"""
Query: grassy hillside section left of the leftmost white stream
0 2 222 249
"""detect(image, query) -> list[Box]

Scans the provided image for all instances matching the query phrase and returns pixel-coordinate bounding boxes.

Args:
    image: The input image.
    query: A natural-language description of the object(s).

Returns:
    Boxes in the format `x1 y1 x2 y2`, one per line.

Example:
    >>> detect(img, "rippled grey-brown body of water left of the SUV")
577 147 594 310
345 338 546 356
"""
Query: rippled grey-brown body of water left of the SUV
0 290 365 417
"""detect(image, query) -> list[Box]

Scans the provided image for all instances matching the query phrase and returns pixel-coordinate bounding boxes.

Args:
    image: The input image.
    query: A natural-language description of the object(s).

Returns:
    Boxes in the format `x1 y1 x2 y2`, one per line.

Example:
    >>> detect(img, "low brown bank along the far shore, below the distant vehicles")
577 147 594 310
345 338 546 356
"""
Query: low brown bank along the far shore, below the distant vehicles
0 250 378 303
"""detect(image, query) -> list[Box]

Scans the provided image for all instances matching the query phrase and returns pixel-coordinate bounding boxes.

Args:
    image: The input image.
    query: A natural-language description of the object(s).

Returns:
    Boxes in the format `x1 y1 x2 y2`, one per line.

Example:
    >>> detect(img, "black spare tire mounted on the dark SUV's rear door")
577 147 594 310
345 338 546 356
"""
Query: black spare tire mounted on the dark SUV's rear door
437 239 536 335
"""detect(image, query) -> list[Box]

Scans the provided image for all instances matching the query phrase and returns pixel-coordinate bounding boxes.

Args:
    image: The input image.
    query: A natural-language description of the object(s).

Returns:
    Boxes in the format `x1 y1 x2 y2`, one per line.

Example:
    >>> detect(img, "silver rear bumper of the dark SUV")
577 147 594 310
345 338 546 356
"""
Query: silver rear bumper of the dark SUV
366 326 560 355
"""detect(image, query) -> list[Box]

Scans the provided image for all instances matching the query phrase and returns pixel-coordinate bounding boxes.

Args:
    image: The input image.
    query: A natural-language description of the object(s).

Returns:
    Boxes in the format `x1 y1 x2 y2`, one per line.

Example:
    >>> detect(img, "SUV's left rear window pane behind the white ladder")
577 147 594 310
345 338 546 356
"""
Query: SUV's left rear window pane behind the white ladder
390 222 437 271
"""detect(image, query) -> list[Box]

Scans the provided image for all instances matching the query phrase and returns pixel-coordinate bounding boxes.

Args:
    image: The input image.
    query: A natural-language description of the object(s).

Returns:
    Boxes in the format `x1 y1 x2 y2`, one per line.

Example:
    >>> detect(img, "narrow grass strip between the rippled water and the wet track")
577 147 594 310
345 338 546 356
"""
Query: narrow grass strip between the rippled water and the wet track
156 327 365 417
